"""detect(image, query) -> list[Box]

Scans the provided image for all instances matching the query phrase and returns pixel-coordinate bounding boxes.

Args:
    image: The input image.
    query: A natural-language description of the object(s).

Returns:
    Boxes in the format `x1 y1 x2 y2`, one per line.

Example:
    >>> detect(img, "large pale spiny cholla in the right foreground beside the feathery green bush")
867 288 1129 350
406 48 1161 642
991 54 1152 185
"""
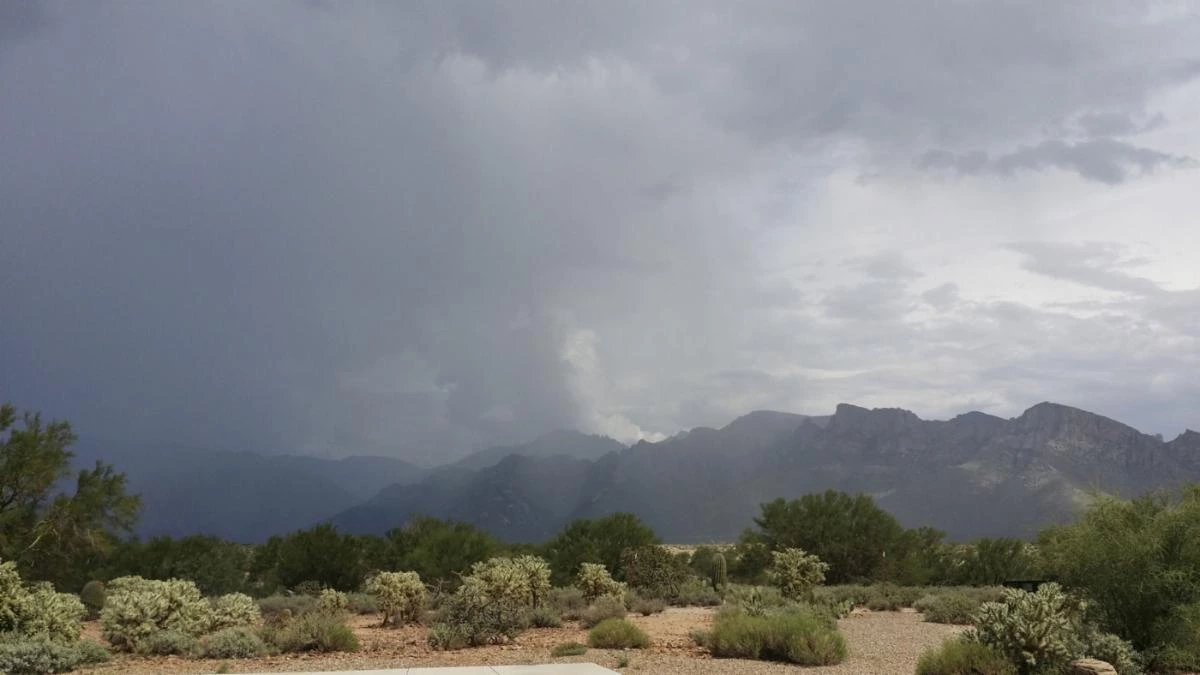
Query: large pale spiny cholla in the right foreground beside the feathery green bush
965 584 1082 675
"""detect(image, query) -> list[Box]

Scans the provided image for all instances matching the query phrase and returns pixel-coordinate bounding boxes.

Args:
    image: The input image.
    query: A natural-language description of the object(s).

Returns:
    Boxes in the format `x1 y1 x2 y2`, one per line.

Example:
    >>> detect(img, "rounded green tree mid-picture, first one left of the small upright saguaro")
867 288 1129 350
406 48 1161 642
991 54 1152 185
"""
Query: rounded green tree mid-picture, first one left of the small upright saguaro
542 513 661 586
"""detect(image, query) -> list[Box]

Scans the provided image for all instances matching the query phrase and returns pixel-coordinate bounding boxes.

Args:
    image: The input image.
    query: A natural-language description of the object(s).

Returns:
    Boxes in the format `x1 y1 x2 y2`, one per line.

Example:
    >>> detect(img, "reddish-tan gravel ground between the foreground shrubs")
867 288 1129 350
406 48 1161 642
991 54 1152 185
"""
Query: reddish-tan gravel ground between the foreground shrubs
75 608 961 675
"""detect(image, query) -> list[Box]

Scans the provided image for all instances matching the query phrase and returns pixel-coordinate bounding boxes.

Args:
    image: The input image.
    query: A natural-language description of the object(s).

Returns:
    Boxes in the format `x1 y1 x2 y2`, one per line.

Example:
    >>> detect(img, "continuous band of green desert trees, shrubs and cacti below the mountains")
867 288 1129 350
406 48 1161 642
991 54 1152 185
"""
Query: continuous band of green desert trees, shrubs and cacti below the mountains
7 406 1200 675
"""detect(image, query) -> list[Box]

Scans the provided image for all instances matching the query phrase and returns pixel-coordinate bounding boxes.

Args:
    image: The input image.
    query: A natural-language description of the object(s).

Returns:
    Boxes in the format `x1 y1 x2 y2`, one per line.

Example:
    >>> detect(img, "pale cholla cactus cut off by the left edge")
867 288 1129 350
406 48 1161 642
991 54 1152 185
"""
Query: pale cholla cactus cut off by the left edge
0 562 88 643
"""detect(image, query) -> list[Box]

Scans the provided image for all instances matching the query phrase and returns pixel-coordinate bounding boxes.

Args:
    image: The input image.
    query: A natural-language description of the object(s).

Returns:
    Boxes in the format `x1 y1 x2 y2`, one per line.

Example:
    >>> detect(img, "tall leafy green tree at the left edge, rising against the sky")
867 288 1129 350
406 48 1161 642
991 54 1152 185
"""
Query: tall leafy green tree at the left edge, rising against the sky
0 404 140 591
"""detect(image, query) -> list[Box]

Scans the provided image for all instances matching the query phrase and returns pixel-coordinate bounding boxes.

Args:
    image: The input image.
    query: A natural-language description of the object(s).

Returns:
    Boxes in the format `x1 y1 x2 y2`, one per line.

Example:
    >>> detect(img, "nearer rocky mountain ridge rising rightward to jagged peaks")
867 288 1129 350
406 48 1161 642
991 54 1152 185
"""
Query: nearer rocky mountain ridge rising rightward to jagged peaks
333 404 1200 542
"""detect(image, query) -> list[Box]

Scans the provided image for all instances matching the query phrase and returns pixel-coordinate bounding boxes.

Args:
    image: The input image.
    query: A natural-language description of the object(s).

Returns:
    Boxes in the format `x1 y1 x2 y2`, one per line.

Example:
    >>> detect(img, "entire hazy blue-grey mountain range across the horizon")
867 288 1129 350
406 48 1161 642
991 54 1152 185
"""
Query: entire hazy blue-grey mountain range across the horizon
77 402 1200 543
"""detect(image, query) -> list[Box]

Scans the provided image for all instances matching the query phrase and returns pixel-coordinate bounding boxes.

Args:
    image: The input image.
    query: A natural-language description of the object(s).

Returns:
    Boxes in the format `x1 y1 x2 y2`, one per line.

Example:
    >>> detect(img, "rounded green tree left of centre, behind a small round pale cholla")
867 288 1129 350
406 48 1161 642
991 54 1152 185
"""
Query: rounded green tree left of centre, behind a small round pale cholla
383 516 502 586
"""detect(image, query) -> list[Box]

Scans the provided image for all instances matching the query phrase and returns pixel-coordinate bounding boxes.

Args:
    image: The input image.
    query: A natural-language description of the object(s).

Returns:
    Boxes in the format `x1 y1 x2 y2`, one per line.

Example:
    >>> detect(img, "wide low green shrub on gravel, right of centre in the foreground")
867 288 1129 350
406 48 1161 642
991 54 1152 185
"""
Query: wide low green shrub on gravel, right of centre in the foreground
708 607 846 665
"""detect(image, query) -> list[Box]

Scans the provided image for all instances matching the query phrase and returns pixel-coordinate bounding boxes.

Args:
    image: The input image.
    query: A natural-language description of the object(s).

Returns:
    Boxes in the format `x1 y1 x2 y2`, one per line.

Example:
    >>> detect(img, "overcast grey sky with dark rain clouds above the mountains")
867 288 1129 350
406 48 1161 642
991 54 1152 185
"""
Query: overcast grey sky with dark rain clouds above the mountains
0 0 1200 461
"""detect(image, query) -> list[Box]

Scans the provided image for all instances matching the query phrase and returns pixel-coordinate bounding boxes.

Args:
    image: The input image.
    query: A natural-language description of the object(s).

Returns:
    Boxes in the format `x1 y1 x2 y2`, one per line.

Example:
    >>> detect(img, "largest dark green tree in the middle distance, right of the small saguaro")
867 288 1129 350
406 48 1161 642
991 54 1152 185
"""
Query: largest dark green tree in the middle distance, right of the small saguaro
743 490 907 584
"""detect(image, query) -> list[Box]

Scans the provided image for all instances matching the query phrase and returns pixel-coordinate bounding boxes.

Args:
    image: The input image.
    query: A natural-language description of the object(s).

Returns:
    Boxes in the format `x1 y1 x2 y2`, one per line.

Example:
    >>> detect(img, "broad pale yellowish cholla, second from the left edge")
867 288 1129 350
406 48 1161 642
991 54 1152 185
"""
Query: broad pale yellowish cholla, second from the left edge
100 577 212 651
